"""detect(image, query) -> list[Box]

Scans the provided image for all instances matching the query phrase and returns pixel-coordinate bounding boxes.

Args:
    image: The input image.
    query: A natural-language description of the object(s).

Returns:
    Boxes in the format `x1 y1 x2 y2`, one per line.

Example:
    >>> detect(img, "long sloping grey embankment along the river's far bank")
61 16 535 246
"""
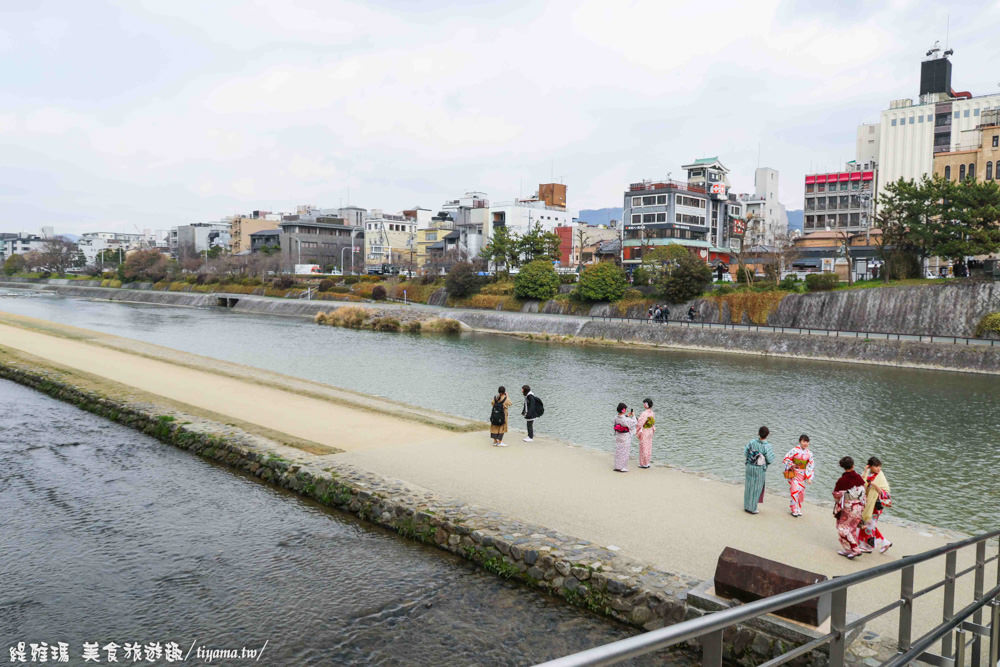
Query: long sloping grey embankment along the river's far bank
7 281 1000 374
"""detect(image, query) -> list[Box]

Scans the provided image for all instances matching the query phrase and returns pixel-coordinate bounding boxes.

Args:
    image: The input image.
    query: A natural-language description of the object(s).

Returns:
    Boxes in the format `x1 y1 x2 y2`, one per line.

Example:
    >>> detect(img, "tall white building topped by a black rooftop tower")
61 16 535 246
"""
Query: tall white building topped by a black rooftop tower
878 48 1000 202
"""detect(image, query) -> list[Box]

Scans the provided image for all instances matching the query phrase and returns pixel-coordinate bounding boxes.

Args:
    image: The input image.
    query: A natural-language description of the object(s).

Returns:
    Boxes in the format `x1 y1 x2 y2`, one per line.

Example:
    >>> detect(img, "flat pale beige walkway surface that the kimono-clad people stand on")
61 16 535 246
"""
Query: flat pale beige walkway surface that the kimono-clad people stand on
0 313 997 648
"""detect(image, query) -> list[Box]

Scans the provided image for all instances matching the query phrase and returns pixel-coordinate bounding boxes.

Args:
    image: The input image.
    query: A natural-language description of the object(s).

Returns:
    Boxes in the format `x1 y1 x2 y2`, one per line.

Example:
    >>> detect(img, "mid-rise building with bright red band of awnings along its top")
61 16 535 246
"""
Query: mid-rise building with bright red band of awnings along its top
802 161 878 234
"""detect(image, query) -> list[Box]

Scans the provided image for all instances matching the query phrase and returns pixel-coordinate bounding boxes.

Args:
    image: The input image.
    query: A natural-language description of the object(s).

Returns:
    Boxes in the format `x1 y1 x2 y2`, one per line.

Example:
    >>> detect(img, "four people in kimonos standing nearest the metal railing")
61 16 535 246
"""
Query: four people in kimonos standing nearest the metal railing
743 426 892 558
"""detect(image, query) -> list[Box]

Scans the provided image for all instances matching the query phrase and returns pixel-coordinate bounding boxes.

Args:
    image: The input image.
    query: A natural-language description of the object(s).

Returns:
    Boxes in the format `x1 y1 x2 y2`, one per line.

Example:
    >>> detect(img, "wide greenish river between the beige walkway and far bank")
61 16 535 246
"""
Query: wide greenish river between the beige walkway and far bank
0 290 1000 531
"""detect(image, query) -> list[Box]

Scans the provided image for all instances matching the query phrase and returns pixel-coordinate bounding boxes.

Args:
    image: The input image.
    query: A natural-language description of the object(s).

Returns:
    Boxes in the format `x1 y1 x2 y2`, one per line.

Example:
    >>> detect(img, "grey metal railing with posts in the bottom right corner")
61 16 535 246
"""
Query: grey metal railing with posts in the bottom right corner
543 530 1000 667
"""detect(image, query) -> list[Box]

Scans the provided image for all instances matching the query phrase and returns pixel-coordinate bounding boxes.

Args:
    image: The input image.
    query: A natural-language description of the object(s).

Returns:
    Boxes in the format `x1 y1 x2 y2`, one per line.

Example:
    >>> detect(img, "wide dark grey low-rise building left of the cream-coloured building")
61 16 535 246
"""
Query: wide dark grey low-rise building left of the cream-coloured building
278 208 365 273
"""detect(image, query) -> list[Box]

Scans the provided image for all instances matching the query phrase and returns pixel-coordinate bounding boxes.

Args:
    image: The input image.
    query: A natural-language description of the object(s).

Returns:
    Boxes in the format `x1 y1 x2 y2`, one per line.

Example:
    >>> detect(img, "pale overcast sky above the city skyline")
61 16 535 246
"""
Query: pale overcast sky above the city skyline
0 0 1000 233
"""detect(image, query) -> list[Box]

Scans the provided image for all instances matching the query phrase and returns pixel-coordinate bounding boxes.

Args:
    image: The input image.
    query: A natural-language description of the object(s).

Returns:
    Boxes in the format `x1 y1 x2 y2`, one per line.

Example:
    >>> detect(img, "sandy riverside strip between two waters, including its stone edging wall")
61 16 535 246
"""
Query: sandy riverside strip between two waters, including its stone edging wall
0 315 996 662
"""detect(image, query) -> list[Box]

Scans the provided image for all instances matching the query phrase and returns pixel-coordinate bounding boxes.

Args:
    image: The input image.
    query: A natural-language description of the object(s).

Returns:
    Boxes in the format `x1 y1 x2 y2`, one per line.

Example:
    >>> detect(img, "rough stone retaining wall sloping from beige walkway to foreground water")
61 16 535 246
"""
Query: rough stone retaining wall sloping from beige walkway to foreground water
0 362 871 666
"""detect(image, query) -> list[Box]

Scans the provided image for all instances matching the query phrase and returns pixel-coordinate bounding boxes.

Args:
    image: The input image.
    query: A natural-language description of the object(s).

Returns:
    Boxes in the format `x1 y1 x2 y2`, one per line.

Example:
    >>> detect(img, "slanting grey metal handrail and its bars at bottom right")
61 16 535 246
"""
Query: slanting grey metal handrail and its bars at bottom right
542 530 1000 667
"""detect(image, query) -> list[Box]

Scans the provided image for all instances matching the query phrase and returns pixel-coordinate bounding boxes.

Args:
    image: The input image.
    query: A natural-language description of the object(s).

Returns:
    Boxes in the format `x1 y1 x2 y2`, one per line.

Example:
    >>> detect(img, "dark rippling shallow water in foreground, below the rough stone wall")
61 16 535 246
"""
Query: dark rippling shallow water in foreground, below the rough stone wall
0 380 687 665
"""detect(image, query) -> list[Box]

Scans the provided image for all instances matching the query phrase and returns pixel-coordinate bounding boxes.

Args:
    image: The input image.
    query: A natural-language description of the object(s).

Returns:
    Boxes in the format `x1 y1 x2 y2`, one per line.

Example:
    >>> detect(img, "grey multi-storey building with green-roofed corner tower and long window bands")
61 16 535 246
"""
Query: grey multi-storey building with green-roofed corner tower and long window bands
622 157 743 267
